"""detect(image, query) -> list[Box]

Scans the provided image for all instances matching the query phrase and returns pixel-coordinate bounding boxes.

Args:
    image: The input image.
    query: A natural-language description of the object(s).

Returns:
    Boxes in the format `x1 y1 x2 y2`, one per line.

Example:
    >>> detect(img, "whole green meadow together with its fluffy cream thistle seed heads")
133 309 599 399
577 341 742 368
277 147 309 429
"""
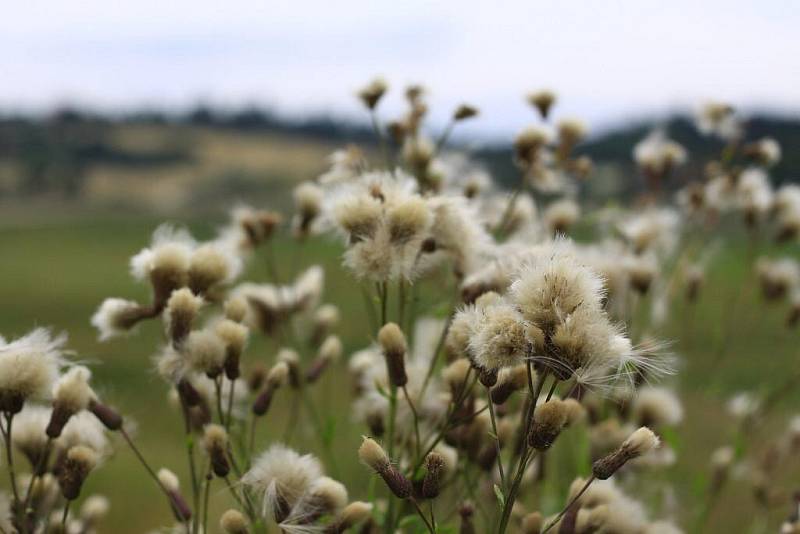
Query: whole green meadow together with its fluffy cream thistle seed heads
0 85 800 534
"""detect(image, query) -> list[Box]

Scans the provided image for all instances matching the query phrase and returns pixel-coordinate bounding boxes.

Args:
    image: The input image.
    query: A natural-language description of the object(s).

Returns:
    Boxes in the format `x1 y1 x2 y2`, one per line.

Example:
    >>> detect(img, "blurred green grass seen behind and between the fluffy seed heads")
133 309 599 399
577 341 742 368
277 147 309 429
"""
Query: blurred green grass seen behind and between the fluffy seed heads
0 213 800 534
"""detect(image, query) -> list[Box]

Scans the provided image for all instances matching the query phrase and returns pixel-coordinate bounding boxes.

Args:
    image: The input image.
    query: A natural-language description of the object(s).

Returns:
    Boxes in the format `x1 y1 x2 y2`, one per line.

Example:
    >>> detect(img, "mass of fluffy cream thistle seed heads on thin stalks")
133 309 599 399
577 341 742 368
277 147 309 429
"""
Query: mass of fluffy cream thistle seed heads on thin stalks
0 79 800 534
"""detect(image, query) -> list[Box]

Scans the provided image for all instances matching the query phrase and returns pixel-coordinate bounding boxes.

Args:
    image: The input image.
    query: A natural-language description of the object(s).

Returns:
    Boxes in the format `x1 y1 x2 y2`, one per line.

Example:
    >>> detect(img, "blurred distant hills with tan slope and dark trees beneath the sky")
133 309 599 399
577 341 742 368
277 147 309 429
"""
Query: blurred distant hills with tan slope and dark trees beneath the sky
0 106 800 207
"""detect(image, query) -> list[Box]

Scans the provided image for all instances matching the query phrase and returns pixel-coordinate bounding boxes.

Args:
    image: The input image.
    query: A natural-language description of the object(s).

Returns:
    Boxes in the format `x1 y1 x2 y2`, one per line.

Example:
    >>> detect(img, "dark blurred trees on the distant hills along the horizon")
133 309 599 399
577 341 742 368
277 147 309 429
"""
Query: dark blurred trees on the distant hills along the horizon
0 105 800 202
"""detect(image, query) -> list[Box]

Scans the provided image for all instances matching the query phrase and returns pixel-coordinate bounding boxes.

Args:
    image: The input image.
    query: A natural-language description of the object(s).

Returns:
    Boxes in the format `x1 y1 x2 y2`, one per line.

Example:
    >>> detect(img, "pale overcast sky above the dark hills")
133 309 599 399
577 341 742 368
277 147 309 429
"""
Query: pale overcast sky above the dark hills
0 0 800 133
